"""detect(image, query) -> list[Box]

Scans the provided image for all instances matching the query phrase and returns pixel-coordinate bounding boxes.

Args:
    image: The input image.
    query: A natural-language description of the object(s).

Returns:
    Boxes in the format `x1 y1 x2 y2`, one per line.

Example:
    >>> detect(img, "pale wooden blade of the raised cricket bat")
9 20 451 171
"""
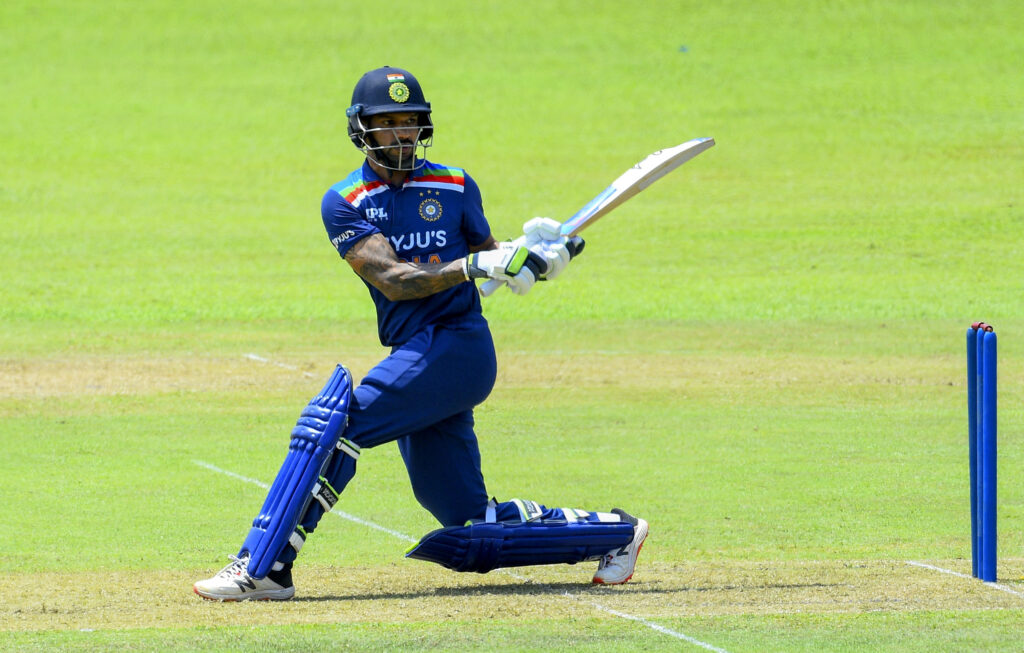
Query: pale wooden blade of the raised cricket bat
561 137 715 236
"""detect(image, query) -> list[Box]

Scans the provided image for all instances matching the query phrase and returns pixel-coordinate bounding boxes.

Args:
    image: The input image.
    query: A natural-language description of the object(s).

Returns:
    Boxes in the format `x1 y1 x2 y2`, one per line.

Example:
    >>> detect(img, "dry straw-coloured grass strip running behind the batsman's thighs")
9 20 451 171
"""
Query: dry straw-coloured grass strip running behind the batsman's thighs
0 349 963 407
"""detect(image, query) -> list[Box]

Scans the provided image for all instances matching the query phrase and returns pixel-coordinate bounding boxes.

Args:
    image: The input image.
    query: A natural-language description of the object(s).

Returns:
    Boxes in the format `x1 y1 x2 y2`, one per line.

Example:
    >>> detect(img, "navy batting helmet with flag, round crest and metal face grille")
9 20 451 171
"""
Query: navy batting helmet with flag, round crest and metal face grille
345 66 434 170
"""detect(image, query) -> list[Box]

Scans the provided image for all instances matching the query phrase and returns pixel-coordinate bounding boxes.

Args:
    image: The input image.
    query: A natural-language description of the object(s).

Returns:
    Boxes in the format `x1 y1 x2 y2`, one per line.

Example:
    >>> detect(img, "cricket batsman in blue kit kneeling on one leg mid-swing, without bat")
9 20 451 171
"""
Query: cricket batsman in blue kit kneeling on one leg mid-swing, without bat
194 67 648 601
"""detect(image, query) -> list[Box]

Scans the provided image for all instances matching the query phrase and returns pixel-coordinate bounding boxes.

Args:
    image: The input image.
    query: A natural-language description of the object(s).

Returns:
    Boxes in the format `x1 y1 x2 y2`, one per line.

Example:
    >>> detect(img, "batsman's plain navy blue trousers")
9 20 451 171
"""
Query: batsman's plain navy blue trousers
294 313 498 540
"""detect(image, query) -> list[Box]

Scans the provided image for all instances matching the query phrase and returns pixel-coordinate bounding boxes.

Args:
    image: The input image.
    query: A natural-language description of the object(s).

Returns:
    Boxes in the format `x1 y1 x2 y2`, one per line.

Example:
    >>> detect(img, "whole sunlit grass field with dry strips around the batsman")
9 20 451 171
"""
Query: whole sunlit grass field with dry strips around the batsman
0 0 1024 653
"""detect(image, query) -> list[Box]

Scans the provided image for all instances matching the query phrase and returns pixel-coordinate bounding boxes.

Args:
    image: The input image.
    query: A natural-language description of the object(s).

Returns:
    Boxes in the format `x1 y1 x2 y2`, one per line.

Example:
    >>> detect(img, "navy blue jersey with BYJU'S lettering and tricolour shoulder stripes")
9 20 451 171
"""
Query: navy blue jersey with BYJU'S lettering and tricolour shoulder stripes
321 161 490 346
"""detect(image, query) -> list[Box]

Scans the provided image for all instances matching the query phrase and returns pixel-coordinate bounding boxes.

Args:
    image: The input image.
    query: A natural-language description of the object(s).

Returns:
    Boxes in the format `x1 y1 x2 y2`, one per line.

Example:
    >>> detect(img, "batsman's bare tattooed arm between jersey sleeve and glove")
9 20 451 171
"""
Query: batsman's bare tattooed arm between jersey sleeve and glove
345 233 466 301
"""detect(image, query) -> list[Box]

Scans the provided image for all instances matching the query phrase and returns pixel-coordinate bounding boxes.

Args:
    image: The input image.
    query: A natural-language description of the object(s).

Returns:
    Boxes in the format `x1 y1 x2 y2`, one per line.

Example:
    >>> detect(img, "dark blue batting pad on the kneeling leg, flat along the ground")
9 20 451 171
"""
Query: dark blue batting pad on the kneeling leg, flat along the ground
406 519 633 573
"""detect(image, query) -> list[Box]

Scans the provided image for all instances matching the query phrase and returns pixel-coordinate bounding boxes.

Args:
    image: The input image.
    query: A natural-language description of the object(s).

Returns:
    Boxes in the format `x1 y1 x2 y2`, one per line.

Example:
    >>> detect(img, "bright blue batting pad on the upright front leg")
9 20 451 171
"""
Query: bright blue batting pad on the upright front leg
239 365 359 578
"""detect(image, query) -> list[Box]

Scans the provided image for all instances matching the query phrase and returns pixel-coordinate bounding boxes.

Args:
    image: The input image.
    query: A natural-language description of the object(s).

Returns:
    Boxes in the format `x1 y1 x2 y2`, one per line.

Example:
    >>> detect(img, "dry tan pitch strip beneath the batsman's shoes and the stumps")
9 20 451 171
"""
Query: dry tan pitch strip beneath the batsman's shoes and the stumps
0 560 1024 630
